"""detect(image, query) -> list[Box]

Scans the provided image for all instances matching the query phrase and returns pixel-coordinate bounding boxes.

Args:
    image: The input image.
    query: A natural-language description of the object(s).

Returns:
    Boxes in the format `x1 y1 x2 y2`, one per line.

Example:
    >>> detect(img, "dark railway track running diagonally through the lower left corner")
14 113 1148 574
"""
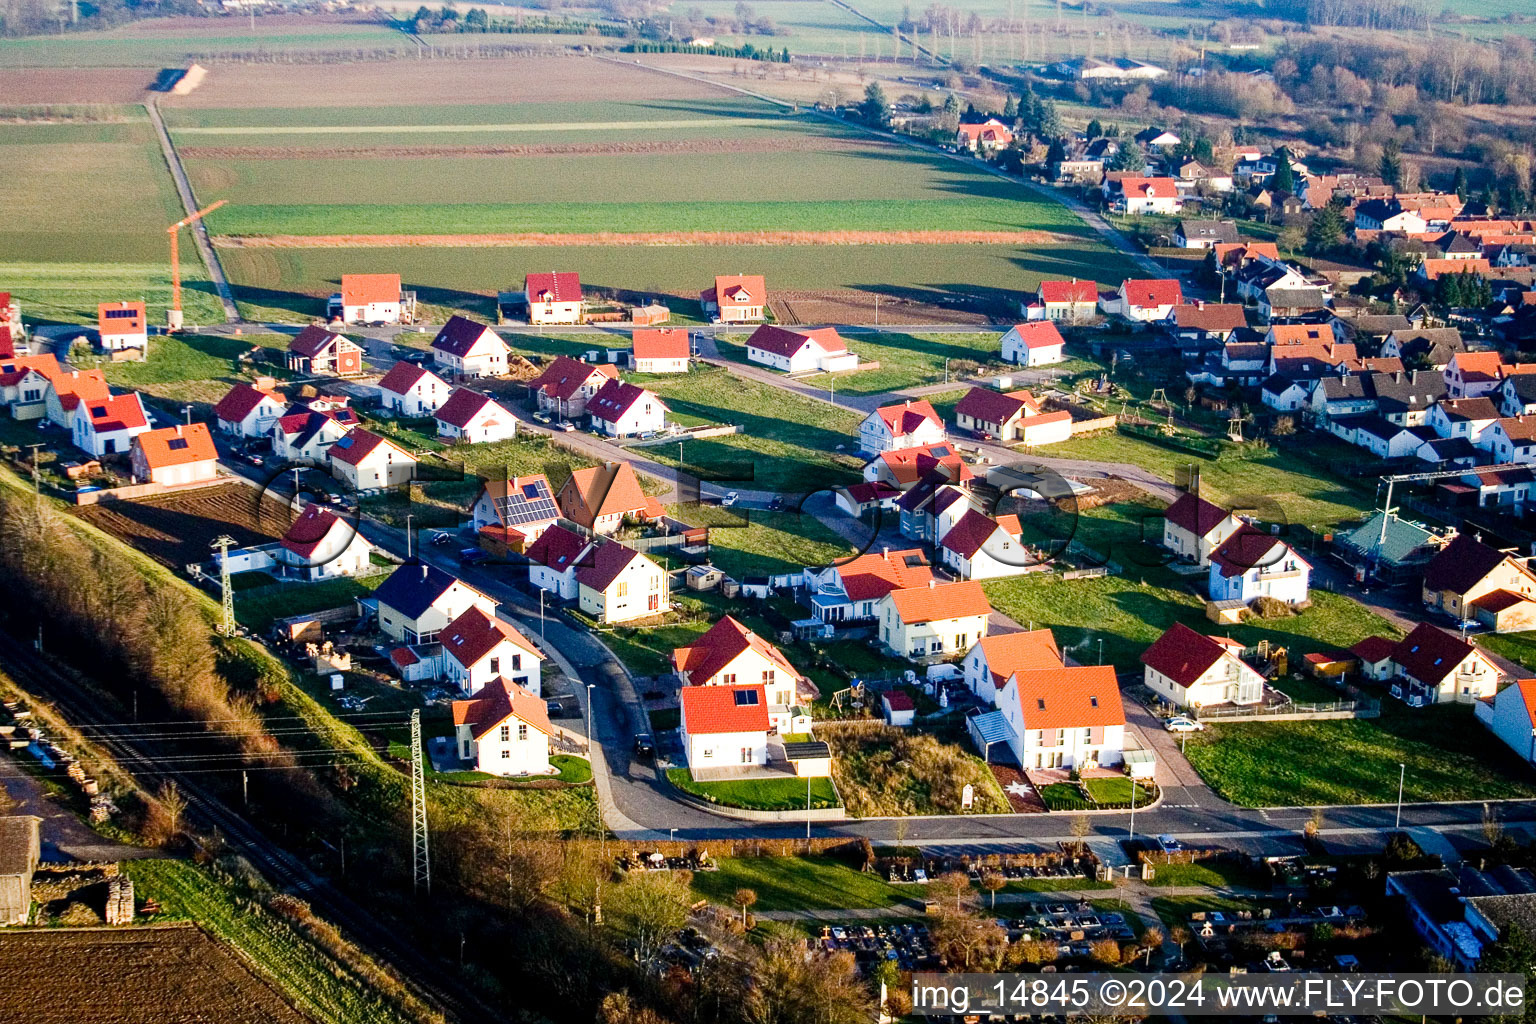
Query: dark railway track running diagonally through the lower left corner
0 631 504 1024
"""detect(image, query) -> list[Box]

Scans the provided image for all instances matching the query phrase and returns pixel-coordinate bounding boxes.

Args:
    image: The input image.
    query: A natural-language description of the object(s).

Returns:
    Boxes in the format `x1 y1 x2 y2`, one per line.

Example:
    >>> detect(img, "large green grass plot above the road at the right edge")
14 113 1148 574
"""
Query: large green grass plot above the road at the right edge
1186 699 1536 806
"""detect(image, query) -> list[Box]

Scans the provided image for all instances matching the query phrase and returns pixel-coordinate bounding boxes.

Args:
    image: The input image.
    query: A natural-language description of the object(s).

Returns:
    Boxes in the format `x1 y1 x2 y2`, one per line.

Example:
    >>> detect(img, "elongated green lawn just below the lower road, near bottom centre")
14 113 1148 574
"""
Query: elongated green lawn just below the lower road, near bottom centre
693 857 903 910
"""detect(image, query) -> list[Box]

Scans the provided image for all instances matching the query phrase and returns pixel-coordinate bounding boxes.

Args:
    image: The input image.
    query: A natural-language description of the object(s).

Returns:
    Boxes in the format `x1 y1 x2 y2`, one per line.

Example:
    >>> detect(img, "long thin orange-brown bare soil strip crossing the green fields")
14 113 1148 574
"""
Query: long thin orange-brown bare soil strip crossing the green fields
214 230 1080 249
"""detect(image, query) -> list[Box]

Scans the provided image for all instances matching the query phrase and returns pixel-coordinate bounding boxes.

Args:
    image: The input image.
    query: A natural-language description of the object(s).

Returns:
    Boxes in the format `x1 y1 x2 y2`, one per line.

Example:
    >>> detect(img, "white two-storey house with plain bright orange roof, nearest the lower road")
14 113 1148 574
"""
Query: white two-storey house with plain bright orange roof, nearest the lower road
997 665 1126 769
